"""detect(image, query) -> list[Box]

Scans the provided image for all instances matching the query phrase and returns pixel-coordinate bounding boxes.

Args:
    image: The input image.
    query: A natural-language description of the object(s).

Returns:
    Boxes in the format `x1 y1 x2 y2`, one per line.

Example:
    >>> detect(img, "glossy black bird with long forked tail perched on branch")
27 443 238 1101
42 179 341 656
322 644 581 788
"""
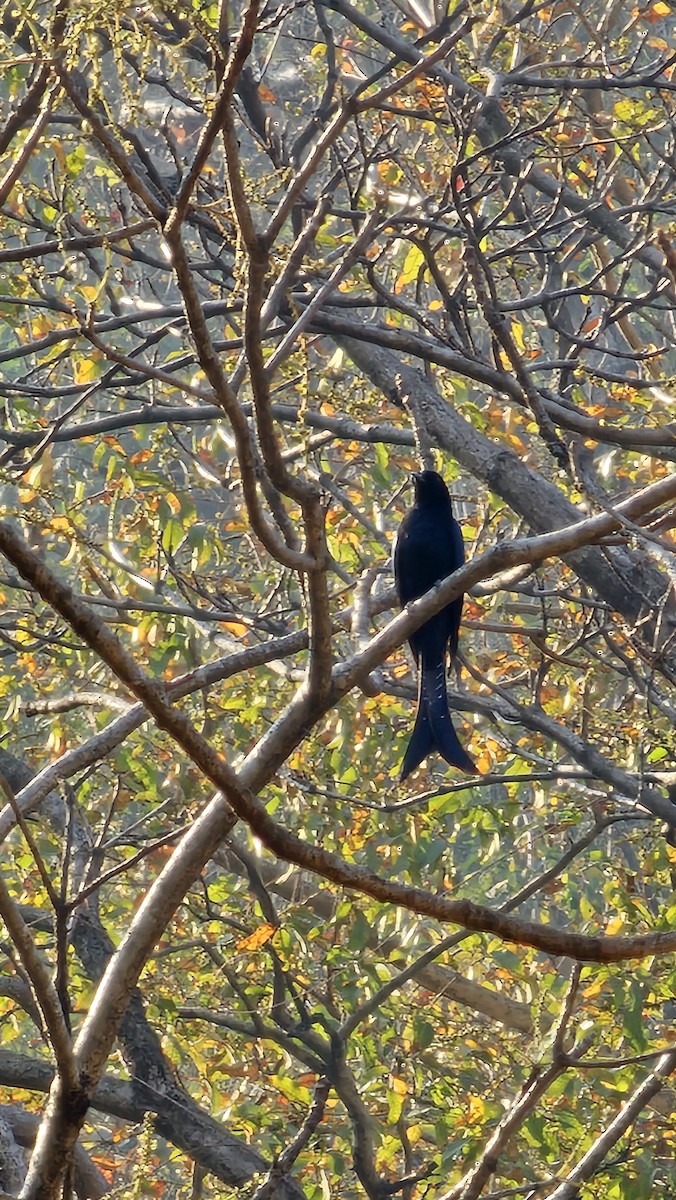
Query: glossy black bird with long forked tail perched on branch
393 470 478 782
